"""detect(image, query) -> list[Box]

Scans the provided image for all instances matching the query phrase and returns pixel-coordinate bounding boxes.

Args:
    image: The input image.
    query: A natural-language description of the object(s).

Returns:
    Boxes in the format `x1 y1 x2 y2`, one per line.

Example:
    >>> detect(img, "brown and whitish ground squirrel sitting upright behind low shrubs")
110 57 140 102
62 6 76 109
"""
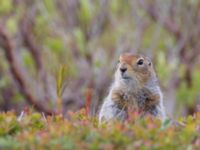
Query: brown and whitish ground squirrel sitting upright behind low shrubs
99 53 166 122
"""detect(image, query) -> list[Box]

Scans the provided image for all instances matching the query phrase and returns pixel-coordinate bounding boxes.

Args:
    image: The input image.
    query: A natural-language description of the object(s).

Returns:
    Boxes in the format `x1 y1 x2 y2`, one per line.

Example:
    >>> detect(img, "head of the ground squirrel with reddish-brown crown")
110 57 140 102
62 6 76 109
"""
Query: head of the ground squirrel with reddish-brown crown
116 53 156 87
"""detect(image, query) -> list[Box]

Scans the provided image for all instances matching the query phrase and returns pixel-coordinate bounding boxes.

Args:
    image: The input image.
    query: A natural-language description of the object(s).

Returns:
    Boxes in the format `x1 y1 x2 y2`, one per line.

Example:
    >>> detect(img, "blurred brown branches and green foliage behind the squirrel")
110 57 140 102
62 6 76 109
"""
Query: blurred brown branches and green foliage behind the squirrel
0 0 200 116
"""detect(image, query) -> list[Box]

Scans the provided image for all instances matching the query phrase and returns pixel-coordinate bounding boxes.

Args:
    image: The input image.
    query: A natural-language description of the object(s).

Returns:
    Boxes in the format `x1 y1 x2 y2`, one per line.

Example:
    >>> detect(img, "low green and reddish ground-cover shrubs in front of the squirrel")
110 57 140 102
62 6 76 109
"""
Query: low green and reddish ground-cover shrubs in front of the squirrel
0 110 200 150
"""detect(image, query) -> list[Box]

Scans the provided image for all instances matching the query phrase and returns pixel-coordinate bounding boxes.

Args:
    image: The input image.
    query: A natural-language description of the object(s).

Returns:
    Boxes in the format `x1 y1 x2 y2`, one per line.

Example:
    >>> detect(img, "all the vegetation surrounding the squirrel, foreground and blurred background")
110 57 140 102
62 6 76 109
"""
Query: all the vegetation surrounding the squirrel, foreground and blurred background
0 0 200 149
